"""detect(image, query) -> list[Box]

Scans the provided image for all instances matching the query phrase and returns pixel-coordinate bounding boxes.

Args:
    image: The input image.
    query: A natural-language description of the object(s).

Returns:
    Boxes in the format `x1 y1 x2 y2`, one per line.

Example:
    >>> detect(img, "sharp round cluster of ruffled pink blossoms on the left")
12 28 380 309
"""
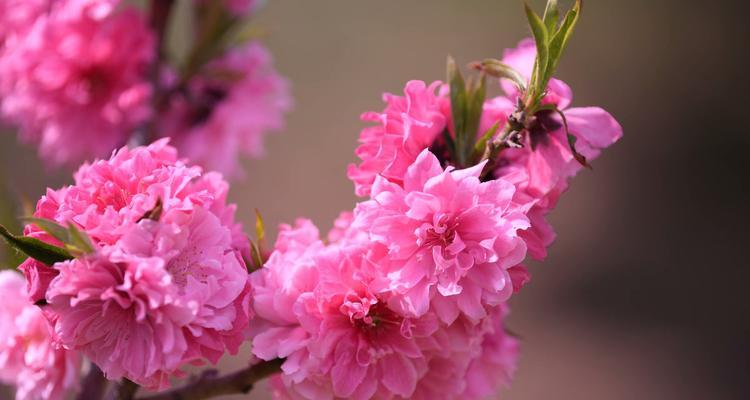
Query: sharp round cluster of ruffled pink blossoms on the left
16 139 252 388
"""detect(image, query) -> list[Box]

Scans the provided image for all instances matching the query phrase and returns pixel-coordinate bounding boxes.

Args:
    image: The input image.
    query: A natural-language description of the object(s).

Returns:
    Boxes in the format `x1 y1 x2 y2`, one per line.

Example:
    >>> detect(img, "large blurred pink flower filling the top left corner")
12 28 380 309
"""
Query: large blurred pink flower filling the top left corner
0 0 154 165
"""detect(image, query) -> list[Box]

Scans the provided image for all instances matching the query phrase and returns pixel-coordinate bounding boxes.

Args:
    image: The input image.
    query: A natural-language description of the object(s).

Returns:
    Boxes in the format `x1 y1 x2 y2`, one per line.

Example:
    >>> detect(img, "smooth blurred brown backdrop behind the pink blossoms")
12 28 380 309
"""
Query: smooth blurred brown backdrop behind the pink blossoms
0 0 750 400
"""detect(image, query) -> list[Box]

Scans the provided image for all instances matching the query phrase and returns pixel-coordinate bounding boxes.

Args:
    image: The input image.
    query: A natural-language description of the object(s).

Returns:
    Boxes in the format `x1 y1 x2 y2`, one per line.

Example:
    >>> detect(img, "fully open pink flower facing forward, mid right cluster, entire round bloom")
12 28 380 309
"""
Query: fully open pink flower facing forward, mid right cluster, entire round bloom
353 150 528 323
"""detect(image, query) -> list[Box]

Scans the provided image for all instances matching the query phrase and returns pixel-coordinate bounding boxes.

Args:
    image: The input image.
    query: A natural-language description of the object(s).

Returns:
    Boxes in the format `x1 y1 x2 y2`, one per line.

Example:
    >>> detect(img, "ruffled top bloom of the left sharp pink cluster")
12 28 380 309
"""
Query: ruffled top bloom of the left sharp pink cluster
25 139 242 245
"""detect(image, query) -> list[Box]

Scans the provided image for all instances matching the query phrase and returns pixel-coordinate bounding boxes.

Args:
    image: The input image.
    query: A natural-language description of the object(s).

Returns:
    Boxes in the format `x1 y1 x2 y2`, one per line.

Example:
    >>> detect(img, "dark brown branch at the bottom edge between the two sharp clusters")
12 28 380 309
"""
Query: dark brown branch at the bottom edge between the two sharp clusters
138 359 284 400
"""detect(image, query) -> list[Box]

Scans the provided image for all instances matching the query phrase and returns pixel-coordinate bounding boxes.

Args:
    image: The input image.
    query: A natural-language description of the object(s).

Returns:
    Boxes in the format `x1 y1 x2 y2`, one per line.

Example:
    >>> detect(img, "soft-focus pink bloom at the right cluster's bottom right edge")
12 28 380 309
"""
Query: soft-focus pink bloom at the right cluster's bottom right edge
461 304 519 399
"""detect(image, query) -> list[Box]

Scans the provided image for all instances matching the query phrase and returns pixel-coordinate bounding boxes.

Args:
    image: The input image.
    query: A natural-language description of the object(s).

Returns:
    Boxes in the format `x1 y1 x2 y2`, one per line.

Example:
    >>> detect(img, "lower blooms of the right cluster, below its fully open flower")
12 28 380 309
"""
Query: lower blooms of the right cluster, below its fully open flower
251 220 517 399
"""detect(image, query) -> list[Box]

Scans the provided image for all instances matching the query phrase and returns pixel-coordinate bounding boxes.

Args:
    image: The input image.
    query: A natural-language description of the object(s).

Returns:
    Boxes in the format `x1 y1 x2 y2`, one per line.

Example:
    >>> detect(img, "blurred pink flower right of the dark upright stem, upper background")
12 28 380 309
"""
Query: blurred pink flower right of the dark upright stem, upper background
160 42 292 175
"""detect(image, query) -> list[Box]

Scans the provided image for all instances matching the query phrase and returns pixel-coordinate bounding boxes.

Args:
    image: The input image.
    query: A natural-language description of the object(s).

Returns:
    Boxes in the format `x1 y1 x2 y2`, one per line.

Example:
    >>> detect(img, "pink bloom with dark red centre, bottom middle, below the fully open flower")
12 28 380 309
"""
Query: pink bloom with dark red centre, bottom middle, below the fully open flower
256 242 446 399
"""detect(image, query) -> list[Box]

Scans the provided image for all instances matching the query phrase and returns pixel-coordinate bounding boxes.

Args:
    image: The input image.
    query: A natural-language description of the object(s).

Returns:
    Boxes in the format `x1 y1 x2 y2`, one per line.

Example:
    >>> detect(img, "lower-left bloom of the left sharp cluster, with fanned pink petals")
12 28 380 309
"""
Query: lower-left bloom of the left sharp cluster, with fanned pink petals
47 250 192 388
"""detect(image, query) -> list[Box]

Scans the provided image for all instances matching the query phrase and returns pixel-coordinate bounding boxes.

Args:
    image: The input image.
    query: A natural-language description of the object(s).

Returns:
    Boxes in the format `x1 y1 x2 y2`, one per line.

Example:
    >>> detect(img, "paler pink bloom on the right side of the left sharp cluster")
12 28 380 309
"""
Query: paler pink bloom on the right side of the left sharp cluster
119 208 250 363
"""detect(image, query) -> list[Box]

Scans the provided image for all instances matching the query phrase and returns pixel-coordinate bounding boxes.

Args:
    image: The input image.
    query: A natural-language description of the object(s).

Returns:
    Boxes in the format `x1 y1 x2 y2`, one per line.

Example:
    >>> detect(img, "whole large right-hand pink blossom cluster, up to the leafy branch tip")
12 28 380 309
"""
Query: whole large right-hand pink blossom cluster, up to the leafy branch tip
251 41 622 399
